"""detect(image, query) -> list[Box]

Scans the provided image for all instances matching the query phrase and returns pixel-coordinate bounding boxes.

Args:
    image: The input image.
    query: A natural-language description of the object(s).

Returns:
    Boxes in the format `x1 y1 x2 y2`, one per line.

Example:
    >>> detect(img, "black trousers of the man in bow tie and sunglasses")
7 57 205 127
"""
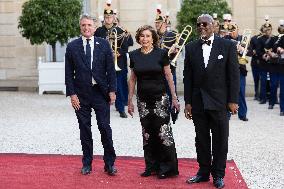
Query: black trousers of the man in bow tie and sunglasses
192 110 229 178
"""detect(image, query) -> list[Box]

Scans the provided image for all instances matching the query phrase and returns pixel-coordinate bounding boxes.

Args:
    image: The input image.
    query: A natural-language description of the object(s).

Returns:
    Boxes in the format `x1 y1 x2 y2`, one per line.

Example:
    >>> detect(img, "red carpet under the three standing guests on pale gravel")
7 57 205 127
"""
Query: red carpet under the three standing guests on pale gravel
0 154 248 189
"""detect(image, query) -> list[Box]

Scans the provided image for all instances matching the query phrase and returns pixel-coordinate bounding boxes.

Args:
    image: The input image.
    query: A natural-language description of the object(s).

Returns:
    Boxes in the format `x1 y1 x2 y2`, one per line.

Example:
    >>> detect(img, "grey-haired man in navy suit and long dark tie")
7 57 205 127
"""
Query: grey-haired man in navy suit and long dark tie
65 15 117 175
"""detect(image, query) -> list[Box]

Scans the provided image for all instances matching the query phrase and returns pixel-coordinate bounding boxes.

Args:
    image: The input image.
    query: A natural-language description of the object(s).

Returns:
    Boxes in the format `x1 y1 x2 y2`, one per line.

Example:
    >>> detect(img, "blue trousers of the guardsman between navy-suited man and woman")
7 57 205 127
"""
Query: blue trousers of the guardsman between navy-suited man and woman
115 70 128 112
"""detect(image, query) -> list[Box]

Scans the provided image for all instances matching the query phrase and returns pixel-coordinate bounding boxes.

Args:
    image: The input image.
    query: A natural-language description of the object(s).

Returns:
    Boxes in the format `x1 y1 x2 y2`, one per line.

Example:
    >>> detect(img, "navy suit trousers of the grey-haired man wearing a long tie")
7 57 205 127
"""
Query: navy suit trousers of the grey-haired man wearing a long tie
75 85 116 166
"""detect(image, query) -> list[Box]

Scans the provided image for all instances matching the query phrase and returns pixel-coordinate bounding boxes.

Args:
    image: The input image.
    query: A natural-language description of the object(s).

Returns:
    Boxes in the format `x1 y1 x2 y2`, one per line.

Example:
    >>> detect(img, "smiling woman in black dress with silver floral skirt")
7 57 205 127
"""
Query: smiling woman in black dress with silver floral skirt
128 25 180 179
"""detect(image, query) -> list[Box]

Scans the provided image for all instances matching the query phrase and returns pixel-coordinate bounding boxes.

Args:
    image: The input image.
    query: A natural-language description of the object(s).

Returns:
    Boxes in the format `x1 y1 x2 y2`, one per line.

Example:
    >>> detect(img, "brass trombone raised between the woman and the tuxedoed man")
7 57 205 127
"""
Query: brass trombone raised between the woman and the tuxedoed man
168 25 192 67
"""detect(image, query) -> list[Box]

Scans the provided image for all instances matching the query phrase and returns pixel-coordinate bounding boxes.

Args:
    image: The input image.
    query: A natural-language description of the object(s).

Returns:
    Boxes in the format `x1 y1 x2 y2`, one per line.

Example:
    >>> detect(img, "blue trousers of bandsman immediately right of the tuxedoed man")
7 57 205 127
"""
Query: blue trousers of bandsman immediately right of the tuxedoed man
238 74 248 118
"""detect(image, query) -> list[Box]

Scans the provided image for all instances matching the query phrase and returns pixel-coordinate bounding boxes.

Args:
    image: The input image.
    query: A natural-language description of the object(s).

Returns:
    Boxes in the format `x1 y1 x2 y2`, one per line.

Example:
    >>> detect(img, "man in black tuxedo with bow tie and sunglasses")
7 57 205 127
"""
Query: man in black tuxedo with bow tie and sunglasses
184 14 240 188
